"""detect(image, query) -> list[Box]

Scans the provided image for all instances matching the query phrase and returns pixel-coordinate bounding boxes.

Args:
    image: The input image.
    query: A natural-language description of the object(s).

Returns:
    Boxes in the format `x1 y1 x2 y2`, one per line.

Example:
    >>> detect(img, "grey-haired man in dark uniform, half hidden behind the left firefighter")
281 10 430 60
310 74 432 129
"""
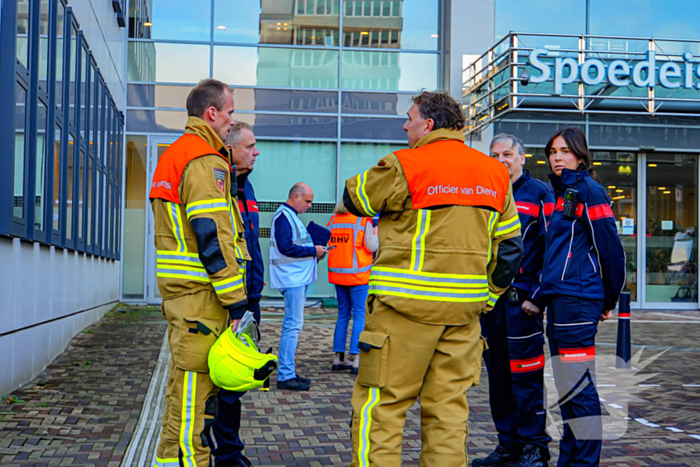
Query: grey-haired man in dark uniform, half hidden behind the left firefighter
210 122 265 467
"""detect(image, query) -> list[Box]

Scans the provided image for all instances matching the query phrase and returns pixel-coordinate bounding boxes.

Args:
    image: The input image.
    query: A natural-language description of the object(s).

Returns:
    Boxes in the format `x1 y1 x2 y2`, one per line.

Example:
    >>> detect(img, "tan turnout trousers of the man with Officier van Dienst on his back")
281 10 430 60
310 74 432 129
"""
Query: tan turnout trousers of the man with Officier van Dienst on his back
351 296 483 467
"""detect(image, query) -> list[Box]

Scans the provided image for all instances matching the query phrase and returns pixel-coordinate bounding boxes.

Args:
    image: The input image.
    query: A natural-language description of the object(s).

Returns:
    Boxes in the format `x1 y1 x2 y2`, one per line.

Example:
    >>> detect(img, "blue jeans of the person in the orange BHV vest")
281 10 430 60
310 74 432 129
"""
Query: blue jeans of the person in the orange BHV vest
333 284 369 355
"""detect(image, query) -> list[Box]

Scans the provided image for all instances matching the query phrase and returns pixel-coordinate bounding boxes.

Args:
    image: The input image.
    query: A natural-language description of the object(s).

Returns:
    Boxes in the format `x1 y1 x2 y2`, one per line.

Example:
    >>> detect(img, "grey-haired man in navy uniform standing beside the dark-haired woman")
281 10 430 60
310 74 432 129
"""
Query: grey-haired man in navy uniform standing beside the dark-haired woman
472 133 554 467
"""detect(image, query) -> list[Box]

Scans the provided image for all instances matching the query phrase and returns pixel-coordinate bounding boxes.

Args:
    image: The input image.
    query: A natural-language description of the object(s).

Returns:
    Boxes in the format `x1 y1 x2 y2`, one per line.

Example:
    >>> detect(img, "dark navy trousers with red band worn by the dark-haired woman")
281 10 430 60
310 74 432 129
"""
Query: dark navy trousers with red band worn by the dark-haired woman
547 295 603 467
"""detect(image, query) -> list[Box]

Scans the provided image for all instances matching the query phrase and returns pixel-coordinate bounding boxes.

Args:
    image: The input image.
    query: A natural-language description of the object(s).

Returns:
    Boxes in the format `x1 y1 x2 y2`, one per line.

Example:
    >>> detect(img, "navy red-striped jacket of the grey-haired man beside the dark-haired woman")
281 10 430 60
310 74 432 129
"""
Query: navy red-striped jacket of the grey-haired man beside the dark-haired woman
511 170 554 308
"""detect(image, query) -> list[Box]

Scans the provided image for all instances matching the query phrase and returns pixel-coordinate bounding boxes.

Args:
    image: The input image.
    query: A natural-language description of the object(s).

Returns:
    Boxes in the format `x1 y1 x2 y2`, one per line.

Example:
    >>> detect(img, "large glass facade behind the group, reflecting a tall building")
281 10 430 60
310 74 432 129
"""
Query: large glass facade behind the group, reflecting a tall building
123 0 444 300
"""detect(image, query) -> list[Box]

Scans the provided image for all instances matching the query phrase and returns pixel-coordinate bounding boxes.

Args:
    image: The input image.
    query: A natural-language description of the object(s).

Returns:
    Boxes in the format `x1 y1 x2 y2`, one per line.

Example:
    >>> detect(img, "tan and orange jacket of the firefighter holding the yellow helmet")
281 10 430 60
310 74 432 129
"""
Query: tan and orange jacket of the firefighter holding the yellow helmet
149 117 250 319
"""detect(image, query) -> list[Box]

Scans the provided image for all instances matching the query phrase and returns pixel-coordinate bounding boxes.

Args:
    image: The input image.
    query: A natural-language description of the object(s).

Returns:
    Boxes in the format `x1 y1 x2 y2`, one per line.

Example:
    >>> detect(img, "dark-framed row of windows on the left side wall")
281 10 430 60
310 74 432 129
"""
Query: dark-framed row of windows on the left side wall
0 0 124 259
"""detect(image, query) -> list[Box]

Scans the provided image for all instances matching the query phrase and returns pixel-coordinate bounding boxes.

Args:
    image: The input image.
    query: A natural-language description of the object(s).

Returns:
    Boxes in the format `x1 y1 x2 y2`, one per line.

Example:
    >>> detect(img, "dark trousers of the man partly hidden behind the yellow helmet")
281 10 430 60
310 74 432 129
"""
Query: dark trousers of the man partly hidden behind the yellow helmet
206 300 261 467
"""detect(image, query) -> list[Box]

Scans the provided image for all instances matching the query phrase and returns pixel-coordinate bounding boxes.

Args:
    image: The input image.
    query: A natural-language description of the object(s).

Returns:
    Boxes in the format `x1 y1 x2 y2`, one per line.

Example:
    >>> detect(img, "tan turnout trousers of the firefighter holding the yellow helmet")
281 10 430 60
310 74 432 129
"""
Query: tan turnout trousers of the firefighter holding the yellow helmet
155 291 228 467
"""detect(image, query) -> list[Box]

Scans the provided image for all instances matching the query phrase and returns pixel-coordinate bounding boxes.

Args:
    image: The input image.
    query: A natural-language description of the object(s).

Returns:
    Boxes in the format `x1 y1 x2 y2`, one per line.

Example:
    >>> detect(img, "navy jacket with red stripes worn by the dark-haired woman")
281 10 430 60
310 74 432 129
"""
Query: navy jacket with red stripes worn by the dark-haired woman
541 169 626 310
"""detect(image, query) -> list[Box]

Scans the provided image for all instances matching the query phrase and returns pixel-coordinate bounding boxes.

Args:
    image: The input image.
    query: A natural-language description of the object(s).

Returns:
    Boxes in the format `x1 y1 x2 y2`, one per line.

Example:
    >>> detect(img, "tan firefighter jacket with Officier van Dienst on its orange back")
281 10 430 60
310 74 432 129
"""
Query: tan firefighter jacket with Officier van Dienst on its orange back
343 129 522 326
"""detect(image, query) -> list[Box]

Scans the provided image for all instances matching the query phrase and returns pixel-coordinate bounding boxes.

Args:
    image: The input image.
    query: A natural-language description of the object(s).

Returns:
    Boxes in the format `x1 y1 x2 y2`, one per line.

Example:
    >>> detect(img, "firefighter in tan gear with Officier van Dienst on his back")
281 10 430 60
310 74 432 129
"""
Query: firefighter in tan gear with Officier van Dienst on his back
343 92 522 467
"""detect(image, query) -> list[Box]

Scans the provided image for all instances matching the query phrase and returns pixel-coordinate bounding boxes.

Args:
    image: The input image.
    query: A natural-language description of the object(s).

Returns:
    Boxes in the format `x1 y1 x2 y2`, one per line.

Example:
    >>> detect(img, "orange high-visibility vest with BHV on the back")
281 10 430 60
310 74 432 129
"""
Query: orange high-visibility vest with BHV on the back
327 214 373 286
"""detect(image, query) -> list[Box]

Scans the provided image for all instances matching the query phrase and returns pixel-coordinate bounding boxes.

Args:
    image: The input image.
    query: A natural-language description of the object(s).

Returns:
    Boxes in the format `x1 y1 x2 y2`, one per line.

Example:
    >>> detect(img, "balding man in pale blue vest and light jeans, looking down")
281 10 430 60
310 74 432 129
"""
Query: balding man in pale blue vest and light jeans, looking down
270 182 328 391
